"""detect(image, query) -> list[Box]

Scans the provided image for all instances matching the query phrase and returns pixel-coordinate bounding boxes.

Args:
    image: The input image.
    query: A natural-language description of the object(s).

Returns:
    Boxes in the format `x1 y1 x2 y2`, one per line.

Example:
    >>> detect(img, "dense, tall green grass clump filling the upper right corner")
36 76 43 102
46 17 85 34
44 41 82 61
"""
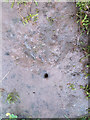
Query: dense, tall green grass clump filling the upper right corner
76 1 90 34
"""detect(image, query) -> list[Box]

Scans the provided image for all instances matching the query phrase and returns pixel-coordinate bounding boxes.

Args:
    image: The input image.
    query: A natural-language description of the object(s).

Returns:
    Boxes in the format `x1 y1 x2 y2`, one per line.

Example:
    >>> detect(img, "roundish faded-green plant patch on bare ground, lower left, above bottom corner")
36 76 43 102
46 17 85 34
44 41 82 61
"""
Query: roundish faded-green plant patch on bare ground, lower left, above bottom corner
6 89 20 104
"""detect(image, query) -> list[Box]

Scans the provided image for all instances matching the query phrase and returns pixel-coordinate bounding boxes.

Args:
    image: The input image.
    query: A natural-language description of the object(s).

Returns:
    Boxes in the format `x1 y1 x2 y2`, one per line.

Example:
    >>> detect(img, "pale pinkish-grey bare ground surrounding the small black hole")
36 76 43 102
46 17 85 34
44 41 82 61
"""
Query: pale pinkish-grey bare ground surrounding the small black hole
0 2 88 118
